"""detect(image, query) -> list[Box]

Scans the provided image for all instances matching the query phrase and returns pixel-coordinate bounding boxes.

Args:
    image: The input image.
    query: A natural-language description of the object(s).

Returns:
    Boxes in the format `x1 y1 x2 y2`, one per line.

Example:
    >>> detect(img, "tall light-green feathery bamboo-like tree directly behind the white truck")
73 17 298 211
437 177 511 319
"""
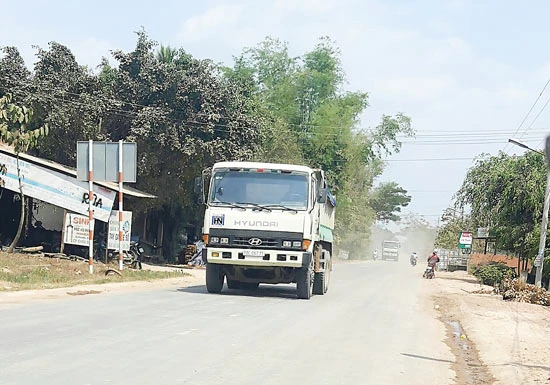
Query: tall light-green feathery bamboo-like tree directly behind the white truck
231 38 412 249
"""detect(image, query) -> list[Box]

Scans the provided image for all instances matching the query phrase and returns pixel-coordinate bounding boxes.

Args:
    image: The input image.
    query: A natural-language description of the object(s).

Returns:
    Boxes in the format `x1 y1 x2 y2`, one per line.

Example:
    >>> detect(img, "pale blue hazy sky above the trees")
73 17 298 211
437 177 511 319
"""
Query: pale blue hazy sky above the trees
0 0 550 224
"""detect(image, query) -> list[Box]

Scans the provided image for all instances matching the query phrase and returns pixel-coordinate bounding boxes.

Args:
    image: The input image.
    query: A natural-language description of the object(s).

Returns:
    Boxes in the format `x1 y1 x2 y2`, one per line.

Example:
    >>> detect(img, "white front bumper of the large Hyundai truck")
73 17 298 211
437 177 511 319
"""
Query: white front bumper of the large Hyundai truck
203 247 311 268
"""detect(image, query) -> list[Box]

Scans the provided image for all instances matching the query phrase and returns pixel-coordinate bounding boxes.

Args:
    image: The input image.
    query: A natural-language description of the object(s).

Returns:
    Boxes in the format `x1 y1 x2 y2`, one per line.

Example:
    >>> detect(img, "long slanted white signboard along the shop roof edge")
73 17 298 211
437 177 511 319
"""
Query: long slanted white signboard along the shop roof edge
0 153 115 222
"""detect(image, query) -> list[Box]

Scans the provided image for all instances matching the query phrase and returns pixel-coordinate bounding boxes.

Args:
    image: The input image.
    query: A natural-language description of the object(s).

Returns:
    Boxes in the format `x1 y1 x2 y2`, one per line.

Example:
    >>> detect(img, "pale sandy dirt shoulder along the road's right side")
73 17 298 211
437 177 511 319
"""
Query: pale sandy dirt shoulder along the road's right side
432 271 550 385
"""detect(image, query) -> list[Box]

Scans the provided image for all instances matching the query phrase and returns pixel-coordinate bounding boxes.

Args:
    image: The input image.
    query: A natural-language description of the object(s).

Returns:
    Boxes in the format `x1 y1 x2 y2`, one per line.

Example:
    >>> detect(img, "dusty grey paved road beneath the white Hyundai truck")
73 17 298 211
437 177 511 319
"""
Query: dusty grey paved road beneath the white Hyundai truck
0 261 454 385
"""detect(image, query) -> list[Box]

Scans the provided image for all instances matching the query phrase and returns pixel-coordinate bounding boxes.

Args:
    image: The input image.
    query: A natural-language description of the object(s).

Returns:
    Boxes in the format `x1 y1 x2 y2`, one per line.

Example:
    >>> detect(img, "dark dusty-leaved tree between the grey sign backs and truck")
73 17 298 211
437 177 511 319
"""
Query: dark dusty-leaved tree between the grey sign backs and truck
102 31 267 254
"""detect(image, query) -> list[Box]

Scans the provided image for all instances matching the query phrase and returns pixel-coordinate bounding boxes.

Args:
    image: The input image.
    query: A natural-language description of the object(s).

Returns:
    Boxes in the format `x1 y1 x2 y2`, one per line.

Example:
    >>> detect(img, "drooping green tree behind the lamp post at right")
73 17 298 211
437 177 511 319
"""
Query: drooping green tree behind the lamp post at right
457 153 547 257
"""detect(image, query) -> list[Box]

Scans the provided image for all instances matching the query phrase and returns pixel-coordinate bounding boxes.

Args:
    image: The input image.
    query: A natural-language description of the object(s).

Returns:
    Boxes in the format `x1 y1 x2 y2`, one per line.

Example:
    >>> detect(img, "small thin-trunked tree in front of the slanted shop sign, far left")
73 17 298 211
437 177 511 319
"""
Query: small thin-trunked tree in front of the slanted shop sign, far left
0 94 48 253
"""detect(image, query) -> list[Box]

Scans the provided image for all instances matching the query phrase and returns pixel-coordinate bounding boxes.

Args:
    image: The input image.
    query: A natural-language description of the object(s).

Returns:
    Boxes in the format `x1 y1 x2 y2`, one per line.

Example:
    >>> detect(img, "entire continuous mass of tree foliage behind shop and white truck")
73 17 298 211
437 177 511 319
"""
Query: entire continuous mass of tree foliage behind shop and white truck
0 30 413 254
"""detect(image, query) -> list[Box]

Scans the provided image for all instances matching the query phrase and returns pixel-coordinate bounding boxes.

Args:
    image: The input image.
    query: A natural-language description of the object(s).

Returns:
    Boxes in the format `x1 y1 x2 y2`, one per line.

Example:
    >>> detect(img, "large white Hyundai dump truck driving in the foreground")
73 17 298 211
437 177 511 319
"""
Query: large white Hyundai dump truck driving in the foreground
195 162 336 299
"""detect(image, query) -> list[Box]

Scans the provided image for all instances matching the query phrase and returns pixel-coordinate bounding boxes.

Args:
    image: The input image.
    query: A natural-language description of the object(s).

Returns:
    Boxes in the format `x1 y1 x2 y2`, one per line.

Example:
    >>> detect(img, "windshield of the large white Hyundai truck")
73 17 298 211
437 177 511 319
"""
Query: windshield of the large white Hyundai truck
209 170 308 210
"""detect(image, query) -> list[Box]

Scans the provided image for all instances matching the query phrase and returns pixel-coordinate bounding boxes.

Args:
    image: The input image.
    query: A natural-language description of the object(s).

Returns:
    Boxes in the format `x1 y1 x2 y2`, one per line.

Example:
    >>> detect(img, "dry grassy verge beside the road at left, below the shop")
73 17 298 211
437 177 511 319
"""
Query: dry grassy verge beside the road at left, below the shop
0 251 185 291
